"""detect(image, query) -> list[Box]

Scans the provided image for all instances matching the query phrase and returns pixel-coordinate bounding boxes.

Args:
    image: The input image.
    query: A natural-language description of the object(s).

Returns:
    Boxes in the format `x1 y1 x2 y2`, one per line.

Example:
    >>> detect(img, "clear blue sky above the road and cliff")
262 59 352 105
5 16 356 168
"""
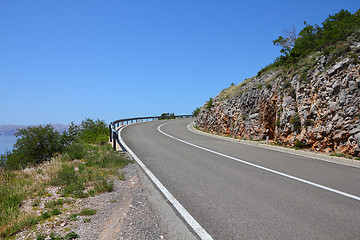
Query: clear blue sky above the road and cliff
0 0 360 124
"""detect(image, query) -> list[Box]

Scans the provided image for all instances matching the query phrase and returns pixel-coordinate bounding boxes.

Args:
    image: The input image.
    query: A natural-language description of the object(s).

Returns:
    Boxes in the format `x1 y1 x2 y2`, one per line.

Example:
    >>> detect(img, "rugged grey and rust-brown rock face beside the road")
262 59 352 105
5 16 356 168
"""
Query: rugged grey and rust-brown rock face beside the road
196 43 360 157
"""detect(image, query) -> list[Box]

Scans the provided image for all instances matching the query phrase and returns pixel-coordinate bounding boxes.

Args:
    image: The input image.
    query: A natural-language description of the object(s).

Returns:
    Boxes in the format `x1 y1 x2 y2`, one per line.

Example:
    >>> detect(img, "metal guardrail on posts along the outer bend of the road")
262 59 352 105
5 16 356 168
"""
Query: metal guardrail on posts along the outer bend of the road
109 115 193 151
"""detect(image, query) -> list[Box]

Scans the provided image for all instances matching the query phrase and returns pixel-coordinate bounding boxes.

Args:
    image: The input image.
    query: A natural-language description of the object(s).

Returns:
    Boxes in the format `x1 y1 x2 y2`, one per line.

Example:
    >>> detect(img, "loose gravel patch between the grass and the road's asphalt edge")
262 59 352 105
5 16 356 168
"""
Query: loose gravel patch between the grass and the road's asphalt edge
15 164 165 240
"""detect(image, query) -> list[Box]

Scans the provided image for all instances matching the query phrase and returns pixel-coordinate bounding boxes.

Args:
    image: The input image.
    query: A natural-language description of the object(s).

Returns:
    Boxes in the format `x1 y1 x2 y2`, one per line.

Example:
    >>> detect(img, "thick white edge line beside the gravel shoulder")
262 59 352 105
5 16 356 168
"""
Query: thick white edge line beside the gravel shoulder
118 126 213 240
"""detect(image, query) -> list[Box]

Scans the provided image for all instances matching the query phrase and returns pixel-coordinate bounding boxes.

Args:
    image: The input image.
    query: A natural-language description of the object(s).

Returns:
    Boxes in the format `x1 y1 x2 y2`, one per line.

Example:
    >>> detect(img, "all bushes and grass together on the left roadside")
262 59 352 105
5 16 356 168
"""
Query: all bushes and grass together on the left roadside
0 119 129 239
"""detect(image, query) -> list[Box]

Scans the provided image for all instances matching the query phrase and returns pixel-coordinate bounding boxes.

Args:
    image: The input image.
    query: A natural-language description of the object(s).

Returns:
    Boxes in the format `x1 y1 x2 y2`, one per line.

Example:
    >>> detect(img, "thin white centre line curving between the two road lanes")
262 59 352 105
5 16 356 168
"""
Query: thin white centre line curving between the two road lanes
158 123 360 201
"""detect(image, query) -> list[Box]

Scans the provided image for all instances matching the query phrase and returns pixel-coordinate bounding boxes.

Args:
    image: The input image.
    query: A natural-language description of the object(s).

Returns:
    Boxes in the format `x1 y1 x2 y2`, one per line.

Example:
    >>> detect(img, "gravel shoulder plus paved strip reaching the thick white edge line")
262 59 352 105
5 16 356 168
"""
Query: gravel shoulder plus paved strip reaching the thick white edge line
15 158 197 240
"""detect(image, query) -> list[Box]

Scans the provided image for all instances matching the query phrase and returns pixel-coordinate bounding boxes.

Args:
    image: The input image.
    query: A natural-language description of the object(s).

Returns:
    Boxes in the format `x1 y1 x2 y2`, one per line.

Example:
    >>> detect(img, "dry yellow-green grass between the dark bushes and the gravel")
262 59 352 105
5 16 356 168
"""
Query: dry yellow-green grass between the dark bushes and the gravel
0 142 129 239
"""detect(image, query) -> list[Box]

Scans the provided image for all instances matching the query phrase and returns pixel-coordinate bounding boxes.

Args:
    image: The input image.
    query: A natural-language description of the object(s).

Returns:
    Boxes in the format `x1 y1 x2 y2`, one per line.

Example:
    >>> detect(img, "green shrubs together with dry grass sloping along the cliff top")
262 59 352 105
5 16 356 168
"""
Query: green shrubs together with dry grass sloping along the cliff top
215 9 360 101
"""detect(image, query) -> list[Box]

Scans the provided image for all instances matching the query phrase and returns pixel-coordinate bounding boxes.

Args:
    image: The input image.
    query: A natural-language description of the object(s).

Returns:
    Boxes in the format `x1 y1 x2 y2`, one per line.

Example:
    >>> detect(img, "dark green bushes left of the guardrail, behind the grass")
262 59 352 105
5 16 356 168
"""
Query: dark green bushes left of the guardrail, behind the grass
0 119 109 169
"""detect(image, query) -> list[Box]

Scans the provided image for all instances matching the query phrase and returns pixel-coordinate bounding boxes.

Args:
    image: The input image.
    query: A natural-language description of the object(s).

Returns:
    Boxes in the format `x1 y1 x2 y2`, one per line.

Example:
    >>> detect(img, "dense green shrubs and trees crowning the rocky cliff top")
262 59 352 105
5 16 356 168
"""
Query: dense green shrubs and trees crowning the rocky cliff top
258 9 360 76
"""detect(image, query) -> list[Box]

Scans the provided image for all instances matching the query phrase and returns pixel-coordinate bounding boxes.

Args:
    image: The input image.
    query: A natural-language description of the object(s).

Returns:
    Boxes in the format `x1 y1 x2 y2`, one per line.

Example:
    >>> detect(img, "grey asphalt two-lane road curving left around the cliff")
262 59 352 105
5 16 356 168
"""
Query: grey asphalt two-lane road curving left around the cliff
121 119 360 239
